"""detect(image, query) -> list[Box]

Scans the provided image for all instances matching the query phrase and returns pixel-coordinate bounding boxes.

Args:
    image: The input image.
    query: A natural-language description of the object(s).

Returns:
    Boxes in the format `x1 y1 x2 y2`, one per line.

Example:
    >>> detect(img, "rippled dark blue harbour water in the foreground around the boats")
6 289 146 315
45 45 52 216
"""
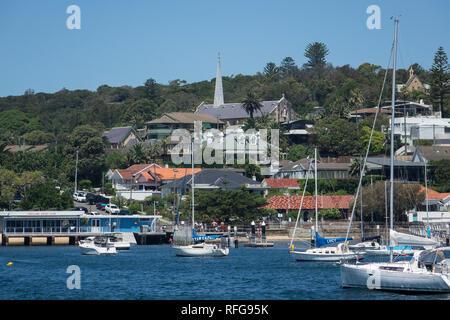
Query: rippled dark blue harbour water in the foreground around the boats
0 243 450 300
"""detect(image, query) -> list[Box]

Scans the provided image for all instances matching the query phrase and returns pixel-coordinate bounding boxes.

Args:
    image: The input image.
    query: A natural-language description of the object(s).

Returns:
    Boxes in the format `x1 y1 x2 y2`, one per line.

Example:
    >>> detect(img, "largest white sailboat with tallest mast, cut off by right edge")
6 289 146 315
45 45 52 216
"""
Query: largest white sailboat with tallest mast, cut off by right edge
341 20 450 292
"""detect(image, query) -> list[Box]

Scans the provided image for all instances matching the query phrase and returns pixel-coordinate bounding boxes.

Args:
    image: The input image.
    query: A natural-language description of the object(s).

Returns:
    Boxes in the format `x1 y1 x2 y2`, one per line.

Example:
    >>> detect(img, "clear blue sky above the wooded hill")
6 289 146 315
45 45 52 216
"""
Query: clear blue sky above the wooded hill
0 0 450 96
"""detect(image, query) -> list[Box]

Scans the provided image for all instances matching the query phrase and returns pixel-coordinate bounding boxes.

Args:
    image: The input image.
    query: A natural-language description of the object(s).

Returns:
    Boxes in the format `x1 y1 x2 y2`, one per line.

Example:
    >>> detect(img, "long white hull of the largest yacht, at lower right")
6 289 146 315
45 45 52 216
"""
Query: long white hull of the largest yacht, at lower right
341 263 450 293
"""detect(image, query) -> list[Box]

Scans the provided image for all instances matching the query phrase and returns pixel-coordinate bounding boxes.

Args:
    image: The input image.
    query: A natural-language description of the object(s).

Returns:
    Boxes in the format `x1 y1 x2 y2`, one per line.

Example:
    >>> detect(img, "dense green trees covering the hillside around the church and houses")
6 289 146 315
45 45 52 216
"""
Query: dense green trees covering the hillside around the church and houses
0 42 450 202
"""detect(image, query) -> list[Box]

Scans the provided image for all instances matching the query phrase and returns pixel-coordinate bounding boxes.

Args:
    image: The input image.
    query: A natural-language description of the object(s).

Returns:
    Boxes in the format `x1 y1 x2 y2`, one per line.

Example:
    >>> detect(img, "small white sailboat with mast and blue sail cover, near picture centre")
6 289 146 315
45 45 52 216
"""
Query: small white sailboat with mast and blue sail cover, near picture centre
171 142 229 257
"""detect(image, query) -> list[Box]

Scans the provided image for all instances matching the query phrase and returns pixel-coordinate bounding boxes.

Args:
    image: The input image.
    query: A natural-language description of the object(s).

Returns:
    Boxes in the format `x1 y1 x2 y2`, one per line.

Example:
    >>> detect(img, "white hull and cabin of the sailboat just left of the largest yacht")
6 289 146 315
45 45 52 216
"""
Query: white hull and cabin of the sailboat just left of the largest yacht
291 243 364 262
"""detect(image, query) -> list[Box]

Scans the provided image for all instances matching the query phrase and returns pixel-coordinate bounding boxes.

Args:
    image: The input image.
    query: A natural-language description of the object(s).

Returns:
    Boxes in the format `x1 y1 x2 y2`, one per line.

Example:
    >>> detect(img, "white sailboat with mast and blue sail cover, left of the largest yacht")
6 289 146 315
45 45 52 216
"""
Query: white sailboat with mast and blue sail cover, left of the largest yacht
290 149 364 262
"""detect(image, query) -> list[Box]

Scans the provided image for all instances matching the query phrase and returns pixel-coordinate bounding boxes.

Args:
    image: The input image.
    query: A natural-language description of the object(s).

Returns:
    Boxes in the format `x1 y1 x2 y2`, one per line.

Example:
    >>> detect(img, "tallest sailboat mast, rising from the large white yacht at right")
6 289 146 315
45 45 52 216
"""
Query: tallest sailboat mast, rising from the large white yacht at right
389 19 398 262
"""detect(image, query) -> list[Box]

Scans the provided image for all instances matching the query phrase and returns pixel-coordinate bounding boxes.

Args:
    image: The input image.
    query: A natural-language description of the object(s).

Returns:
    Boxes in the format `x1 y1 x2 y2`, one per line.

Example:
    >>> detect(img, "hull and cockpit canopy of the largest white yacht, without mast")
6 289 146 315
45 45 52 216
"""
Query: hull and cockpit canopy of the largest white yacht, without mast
341 248 450 292
